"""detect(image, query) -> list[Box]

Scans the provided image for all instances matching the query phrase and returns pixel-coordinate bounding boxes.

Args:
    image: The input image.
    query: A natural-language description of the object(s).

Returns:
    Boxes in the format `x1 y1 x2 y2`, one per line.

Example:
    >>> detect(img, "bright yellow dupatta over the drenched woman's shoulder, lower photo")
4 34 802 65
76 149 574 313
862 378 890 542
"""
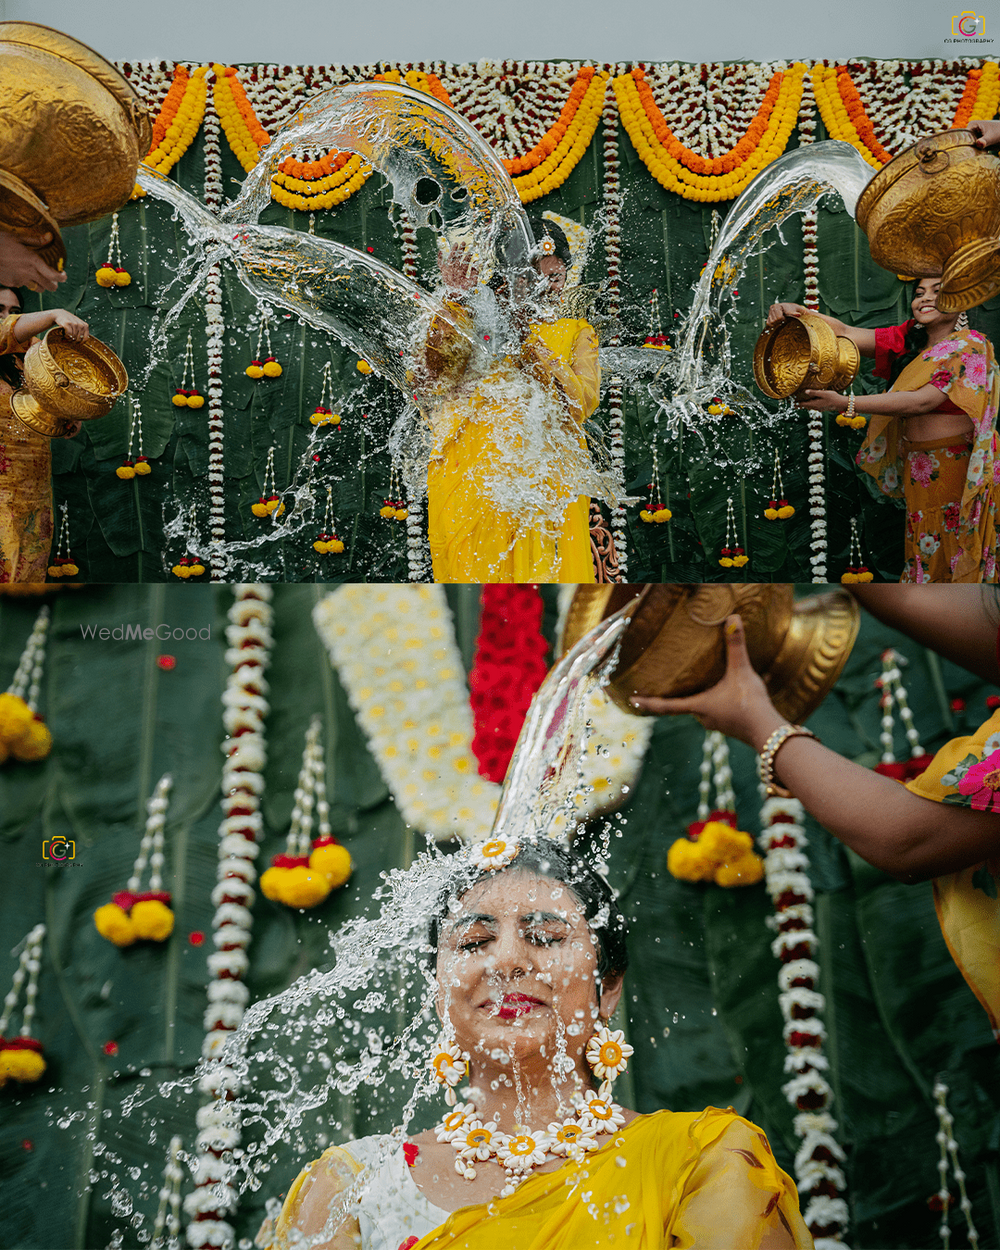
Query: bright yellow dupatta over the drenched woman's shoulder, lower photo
413 1108 813 1250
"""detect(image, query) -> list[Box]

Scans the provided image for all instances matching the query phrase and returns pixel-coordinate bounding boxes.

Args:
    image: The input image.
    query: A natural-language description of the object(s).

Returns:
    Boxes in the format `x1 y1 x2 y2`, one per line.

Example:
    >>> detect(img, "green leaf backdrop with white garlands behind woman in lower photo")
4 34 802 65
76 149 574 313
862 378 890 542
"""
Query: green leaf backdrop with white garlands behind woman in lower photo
0 586 1000 1250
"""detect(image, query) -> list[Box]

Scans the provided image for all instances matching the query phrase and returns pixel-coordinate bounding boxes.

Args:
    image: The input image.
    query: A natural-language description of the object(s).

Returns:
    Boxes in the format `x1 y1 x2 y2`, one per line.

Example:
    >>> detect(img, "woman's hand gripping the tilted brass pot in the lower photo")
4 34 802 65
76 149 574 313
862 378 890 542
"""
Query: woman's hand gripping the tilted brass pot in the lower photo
631 616 785 751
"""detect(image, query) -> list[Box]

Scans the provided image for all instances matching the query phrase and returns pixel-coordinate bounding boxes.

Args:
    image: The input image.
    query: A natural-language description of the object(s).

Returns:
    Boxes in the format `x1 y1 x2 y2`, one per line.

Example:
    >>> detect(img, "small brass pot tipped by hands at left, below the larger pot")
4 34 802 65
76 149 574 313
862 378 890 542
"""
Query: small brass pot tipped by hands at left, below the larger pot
10 326 129 439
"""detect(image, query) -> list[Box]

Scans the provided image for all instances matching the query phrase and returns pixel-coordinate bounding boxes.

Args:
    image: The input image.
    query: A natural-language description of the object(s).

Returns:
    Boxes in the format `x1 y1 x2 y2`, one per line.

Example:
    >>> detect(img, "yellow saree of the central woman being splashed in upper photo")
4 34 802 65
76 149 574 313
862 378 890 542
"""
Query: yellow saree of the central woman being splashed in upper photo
428 318 600 583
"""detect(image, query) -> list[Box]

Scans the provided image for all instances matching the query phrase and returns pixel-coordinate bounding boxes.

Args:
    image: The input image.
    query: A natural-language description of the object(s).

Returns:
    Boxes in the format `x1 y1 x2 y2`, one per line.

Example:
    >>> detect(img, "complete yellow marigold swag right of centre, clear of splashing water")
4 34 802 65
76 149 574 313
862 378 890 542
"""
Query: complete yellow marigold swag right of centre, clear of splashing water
614 61 806 203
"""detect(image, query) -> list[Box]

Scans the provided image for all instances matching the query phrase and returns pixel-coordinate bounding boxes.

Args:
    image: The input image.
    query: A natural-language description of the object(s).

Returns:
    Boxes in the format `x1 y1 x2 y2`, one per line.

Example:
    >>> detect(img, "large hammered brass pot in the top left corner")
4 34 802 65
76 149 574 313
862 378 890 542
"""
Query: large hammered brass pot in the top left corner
0 21 153 264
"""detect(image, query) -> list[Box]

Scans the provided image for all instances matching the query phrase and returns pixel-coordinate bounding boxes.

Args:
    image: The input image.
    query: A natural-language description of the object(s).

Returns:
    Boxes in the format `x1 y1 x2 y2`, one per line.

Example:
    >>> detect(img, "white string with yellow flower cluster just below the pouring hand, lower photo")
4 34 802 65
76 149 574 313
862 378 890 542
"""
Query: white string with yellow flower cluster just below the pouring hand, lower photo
666 730 764 889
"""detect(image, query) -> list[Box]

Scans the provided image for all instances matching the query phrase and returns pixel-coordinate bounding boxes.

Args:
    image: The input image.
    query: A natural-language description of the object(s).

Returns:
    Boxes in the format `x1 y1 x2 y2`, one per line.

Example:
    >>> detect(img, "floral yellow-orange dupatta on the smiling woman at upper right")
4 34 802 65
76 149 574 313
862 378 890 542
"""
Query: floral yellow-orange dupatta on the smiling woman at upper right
856 330 1000 581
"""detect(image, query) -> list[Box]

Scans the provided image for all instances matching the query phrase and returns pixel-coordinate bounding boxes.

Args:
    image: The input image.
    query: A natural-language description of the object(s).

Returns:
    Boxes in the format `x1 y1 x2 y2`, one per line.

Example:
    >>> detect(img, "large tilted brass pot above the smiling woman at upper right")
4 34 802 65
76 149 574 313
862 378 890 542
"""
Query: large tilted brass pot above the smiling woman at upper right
858 130 1000 313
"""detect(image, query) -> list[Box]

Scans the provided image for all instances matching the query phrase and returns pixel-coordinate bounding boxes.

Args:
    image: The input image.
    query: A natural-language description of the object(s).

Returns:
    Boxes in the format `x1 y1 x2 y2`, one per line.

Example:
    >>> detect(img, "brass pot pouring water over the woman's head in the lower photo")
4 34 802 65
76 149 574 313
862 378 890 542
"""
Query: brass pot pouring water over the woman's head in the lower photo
563 583 860 724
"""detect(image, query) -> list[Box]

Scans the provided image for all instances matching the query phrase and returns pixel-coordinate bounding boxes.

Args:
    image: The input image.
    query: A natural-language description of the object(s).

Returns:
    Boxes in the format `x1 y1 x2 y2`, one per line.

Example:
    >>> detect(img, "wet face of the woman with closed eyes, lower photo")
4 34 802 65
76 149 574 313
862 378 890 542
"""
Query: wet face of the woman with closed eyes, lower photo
438 869 621 1071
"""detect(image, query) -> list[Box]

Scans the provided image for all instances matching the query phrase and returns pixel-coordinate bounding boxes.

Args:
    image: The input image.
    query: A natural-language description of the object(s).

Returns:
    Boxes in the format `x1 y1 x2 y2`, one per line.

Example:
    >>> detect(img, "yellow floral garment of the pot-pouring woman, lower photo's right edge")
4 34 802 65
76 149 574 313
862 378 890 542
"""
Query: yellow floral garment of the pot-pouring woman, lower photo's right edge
906 710 1000 1041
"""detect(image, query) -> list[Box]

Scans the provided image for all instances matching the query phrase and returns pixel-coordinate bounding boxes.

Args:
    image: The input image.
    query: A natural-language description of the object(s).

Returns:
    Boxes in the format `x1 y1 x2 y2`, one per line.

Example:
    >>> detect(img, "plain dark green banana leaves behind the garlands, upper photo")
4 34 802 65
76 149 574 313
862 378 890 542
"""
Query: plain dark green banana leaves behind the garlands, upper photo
21 58 1000 581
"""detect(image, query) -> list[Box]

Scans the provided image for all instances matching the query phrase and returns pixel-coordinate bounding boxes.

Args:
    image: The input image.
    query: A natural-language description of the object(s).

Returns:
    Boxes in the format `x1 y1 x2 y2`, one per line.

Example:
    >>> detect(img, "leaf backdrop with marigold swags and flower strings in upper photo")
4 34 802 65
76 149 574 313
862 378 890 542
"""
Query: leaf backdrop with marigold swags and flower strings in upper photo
19 59 1000 581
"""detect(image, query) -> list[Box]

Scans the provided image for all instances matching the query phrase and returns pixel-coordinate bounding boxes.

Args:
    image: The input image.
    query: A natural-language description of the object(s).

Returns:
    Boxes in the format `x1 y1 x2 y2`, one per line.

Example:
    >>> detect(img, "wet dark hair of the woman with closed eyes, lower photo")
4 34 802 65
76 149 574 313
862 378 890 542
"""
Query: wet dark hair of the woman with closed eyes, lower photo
428 840 629 991
